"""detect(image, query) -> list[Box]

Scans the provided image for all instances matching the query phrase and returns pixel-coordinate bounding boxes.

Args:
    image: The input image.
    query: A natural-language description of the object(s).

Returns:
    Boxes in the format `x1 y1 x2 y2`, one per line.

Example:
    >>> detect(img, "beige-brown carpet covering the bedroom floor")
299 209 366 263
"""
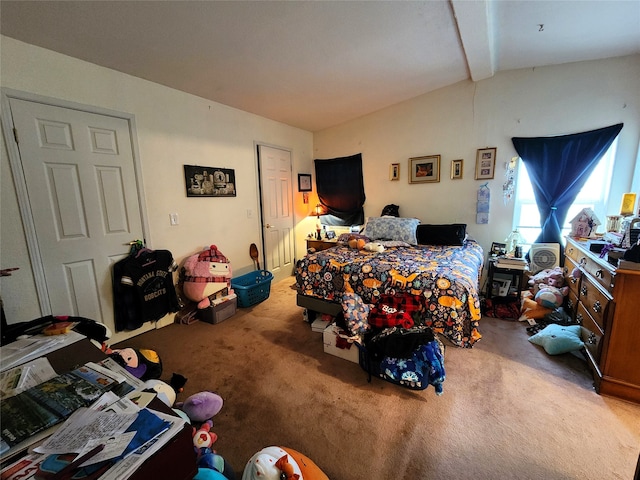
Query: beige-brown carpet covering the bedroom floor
118 279 640 480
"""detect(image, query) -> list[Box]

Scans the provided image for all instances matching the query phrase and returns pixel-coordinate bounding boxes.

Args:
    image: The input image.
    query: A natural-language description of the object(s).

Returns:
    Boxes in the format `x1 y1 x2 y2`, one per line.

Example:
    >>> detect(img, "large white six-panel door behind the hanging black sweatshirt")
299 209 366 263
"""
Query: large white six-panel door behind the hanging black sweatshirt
9 98 148 336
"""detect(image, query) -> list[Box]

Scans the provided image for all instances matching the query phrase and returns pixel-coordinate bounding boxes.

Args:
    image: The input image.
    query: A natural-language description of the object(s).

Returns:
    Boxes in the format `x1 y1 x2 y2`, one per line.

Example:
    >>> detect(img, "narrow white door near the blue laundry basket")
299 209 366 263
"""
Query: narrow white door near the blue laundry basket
258 145 295 281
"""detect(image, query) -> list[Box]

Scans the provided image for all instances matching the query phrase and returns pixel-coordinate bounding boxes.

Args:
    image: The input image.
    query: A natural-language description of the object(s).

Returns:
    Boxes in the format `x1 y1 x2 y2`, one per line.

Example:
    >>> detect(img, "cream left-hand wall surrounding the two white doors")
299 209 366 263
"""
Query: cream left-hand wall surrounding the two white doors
0 36 313 323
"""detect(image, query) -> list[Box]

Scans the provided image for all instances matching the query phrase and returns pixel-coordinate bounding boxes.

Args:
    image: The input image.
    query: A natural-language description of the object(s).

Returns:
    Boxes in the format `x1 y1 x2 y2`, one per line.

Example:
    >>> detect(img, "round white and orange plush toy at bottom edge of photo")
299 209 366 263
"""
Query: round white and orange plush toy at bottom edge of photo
242 446 329 480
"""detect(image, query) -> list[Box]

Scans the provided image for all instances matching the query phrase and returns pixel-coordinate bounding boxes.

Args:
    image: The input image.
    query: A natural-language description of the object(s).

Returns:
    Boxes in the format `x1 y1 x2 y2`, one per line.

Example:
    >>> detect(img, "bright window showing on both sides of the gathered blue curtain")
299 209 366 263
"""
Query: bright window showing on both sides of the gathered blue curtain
513 139 618 251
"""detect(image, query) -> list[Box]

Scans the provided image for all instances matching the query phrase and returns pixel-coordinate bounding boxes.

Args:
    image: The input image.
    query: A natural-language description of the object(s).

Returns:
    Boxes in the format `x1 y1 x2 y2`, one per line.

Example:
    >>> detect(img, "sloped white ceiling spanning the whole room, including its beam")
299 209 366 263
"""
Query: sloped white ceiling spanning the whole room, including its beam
0 0 640 132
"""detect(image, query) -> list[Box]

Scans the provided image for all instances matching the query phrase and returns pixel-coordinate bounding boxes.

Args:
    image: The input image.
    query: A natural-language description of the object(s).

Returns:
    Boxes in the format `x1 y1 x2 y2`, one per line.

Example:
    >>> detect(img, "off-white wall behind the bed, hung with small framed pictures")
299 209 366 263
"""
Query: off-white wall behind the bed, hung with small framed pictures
314 55 640 255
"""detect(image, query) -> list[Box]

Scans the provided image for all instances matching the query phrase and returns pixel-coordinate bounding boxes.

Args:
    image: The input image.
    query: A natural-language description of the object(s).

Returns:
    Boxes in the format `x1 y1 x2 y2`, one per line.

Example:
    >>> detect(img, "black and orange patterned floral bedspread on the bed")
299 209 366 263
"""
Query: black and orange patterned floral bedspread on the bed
296 240 484 347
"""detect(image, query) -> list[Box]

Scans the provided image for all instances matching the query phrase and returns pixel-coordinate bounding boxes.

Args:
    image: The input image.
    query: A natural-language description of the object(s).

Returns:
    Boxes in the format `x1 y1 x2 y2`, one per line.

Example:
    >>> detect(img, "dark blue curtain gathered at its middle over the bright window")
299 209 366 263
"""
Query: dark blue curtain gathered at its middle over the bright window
511 123 623 245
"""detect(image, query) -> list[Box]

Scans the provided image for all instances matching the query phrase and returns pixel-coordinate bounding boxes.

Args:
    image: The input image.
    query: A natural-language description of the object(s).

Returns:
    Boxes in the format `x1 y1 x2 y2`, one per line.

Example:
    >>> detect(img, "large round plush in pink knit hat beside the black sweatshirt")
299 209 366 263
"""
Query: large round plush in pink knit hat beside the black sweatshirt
182 245 233 309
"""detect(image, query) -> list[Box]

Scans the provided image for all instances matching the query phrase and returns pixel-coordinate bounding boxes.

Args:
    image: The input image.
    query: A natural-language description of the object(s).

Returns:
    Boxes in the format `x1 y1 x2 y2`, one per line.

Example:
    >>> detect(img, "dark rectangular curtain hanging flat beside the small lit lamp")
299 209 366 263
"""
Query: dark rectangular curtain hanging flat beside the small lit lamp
314 153 366 225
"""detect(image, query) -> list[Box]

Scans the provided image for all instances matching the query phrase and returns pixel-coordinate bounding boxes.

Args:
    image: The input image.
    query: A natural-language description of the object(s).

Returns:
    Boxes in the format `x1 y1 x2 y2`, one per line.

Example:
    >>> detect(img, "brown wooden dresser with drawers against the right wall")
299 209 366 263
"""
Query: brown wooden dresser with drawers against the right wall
564 238 640 403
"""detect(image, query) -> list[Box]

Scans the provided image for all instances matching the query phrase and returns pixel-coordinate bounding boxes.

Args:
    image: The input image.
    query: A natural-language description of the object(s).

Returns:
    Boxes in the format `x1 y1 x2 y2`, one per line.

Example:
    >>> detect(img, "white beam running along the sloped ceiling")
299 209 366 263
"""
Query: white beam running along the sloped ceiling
451 0 496 82
